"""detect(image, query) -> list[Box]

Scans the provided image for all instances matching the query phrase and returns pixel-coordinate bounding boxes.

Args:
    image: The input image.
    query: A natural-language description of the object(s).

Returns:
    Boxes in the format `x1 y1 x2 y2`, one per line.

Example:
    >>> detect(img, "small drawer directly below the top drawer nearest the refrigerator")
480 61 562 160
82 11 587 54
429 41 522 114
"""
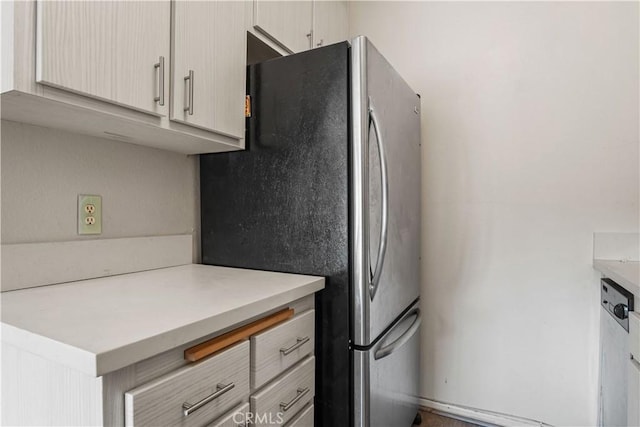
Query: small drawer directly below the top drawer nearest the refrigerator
250 356 316 425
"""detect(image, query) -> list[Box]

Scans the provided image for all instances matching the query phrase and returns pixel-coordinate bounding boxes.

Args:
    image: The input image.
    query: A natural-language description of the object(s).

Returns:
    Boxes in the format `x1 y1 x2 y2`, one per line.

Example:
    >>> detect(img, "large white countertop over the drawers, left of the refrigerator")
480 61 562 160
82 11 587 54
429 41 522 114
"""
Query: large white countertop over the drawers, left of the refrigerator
1 264 324 376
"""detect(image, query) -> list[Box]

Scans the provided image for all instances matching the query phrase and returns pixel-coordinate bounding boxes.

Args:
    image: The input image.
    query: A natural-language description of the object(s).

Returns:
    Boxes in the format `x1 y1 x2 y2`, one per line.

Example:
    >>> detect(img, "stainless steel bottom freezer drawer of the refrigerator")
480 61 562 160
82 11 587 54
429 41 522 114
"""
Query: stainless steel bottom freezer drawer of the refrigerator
354 304 420 427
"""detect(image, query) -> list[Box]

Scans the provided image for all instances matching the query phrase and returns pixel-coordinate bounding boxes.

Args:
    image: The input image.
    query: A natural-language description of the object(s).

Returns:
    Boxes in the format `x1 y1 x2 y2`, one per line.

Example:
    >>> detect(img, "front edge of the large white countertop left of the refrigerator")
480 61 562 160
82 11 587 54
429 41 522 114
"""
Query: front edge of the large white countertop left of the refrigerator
0 276 325 377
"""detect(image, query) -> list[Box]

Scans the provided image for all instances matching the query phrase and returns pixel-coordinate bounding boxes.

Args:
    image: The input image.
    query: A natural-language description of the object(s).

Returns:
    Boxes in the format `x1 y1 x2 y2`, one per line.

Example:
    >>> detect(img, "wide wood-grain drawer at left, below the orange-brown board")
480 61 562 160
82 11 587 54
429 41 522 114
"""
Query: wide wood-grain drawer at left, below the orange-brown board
125 341 249 427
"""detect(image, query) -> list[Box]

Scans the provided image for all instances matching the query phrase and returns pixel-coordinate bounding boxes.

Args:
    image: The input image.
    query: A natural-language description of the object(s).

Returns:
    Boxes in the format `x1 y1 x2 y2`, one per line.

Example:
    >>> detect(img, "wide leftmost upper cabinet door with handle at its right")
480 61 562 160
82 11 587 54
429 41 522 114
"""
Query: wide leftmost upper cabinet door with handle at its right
36 0 171 115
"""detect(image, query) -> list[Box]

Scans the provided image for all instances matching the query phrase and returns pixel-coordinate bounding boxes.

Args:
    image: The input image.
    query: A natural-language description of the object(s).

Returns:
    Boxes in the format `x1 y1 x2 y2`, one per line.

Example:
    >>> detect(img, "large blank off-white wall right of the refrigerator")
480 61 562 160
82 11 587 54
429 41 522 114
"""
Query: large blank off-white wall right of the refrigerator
350 2 640 425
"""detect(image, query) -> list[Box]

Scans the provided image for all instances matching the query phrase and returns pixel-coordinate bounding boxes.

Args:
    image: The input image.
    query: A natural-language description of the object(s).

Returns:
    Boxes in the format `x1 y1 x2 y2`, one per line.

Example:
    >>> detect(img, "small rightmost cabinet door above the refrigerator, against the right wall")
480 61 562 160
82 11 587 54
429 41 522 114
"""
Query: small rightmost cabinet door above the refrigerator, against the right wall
313 0 349 47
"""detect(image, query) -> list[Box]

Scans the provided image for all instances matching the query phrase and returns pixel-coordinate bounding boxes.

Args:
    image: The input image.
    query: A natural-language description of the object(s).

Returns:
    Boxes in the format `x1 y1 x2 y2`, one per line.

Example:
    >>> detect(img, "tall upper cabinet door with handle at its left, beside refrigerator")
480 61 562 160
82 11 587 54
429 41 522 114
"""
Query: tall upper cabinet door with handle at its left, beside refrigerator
171 1 250 139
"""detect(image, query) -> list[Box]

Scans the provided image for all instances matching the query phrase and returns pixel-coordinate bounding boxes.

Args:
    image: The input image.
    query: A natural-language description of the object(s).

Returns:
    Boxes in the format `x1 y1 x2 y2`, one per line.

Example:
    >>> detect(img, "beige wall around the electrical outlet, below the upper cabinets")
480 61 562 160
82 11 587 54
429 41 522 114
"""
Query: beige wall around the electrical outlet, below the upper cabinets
1 120 200 260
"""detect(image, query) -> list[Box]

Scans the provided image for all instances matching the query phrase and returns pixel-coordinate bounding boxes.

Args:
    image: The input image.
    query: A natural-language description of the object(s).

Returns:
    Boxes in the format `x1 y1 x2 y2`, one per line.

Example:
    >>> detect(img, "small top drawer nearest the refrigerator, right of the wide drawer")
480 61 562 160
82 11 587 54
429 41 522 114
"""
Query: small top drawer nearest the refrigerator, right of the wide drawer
251 310 315 390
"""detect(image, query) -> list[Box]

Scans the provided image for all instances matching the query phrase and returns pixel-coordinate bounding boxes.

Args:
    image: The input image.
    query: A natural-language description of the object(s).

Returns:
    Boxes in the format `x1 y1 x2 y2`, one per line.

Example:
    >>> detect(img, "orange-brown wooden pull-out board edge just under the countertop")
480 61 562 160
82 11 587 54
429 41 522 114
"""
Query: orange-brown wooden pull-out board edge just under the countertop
184 308 293 362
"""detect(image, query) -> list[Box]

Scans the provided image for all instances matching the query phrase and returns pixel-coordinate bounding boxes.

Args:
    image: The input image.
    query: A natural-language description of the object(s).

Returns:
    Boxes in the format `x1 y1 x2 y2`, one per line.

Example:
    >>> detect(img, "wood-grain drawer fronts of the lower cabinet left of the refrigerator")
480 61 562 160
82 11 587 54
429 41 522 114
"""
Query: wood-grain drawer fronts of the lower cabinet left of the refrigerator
122 309 315 427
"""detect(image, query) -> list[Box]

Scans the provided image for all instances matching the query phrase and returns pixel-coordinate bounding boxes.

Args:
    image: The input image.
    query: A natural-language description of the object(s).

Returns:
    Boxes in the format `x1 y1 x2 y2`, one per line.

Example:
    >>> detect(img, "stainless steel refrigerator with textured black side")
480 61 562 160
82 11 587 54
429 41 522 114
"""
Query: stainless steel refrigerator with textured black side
200 37 421 426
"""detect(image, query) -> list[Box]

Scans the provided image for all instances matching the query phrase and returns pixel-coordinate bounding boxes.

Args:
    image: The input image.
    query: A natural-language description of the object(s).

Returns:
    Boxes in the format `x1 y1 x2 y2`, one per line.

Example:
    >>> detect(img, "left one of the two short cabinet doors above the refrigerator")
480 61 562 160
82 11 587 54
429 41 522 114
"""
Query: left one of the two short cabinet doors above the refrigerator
253 0 313 52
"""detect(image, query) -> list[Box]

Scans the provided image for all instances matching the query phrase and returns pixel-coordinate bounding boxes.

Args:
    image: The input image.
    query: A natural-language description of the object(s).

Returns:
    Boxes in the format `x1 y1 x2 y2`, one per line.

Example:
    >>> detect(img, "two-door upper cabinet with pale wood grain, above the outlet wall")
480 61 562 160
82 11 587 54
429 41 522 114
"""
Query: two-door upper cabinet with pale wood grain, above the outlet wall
0 0 248 154
